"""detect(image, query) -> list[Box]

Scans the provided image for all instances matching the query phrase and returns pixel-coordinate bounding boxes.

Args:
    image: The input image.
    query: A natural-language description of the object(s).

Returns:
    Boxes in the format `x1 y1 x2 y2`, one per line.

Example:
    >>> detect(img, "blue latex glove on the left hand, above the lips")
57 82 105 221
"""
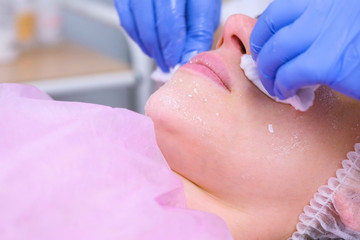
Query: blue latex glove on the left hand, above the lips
115 0 221 72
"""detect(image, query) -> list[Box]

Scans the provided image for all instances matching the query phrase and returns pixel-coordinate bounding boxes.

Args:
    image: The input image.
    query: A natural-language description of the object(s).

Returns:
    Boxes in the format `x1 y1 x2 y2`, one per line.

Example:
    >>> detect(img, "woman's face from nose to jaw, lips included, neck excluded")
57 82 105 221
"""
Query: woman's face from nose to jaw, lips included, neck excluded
146 15 358 238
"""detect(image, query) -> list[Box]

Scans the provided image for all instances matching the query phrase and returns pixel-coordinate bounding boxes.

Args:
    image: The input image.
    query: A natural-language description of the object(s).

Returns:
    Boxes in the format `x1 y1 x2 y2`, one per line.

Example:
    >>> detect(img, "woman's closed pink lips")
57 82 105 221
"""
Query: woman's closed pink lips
183 52 231 91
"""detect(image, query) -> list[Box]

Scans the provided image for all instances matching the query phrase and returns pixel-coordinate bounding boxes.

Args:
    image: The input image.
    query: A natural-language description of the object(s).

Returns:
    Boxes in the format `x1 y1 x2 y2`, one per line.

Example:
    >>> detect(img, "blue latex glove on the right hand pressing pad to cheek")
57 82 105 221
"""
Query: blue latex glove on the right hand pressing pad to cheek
250 0 360 100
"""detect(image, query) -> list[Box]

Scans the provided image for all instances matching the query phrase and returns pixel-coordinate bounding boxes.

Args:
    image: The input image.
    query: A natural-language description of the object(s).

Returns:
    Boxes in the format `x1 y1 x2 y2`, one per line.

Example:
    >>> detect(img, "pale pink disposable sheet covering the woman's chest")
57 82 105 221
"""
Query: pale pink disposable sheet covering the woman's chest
0 84 231 240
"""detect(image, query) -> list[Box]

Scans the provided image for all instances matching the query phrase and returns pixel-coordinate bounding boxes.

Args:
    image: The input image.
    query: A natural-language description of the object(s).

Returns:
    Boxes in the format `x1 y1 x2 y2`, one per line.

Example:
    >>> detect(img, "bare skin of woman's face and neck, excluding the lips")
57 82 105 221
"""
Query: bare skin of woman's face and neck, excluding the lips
146 15 360 240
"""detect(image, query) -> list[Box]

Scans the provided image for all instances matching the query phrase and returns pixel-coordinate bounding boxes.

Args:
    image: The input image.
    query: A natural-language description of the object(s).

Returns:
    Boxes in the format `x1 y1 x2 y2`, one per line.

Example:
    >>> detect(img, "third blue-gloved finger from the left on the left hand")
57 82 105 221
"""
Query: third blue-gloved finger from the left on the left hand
155 0 186 67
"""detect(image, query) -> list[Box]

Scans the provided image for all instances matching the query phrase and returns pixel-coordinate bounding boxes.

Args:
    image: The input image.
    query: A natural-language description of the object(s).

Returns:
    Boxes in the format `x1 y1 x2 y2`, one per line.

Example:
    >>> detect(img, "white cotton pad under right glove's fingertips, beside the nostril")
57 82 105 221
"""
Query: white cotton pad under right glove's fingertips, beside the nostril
240 55 319 112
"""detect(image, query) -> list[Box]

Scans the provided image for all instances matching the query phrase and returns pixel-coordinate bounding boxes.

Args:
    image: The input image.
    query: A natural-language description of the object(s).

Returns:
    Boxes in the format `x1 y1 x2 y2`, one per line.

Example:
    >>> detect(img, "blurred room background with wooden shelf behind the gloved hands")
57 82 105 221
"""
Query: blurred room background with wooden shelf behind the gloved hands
0 0 269 113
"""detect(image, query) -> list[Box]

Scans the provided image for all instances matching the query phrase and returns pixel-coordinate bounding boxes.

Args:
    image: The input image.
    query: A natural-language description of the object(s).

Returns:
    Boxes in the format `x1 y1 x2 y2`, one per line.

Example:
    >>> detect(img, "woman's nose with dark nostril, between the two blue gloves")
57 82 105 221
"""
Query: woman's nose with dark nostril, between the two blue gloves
216 14 256 54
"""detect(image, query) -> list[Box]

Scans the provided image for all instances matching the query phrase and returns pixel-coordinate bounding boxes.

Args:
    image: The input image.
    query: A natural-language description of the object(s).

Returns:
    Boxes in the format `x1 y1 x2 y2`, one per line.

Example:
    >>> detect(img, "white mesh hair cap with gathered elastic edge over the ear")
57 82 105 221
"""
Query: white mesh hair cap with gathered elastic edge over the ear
289 143 360 240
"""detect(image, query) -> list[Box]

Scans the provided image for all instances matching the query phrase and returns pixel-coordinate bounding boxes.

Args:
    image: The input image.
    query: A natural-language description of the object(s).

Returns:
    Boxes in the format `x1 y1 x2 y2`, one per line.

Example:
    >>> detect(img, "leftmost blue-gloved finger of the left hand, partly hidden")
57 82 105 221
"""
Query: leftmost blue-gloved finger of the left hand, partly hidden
114 0 150 56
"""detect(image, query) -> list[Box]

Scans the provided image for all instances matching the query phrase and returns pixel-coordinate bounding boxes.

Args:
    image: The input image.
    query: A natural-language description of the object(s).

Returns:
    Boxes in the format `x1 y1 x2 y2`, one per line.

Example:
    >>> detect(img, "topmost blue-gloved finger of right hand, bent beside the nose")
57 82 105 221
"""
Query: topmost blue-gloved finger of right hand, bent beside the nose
250 0 311 61
